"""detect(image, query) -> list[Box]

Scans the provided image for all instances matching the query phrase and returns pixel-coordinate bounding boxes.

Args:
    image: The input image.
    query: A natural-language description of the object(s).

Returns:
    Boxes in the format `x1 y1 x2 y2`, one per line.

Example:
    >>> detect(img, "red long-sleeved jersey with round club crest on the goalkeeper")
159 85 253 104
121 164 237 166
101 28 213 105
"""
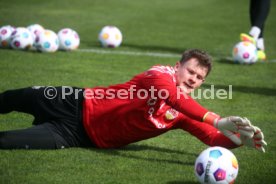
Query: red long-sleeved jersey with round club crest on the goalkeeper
83 66 235 148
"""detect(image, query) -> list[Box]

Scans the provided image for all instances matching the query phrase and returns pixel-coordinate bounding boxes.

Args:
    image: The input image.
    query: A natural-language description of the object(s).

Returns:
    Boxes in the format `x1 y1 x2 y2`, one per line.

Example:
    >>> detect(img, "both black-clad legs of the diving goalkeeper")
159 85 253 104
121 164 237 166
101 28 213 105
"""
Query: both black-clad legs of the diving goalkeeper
0 87 94 149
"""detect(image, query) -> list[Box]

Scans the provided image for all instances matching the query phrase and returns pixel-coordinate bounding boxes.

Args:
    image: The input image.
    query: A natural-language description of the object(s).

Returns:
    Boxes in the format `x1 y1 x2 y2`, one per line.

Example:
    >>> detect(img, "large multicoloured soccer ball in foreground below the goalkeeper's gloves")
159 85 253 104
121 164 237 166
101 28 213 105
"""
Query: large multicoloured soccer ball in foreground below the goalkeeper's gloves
195 146 239 184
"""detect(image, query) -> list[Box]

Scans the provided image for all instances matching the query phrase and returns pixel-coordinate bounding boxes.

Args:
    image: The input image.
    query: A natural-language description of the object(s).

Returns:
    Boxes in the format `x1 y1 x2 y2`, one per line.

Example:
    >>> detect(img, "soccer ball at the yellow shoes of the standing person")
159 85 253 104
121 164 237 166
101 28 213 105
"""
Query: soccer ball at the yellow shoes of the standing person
232 42 258 64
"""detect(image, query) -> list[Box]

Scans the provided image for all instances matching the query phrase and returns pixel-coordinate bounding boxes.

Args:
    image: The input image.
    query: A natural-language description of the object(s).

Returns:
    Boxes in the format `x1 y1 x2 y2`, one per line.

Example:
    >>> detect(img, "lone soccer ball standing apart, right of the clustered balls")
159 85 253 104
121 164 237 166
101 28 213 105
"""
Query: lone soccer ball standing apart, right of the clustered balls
99 26 123 48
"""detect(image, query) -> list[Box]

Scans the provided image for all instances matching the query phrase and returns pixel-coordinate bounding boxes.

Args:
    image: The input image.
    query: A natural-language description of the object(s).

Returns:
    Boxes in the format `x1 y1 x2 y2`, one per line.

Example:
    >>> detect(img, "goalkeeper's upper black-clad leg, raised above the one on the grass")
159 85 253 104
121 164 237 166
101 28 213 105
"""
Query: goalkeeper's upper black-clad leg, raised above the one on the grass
0 87 82 124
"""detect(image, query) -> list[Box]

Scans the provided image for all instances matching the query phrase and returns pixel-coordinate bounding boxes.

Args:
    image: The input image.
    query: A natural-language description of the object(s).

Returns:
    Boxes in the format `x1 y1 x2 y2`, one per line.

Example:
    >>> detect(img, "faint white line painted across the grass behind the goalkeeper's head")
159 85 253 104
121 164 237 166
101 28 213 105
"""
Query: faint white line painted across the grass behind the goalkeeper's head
77 49 276 62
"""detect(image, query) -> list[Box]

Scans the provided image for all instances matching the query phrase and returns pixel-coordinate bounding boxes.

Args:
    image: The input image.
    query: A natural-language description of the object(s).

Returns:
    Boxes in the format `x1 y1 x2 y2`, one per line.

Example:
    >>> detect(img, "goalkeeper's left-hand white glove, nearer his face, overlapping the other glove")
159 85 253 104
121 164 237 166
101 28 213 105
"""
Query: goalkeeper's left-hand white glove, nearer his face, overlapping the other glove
214 116 256 138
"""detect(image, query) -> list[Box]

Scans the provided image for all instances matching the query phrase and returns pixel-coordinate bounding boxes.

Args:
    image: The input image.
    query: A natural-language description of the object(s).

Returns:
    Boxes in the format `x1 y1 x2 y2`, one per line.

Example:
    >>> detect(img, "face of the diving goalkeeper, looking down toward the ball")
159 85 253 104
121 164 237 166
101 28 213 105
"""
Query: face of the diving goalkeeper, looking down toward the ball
174 58 208 94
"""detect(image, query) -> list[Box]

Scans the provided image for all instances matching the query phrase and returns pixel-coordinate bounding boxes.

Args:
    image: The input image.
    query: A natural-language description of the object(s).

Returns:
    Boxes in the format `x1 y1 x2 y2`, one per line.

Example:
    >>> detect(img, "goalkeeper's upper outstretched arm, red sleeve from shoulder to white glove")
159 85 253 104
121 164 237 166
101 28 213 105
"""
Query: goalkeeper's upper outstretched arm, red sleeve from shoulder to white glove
140 67 260 145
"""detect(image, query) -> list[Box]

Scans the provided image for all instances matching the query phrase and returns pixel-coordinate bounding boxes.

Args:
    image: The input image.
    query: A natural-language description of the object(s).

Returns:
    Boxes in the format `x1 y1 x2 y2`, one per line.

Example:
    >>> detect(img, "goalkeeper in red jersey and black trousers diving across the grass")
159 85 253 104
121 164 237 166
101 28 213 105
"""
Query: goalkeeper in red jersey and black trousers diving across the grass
0 49 266 152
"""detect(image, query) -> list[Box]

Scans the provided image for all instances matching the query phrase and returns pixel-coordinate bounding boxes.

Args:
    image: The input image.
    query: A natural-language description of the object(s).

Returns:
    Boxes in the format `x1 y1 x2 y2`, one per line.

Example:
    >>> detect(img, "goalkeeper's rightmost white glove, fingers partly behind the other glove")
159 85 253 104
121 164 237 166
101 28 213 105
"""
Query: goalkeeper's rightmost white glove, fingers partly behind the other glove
240 126 267 153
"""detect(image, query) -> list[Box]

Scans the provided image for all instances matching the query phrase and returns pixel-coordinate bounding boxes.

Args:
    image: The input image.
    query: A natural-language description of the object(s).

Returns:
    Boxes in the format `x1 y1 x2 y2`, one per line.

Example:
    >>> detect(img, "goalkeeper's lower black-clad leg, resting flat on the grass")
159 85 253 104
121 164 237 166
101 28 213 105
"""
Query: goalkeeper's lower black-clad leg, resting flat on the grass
0 122 95 149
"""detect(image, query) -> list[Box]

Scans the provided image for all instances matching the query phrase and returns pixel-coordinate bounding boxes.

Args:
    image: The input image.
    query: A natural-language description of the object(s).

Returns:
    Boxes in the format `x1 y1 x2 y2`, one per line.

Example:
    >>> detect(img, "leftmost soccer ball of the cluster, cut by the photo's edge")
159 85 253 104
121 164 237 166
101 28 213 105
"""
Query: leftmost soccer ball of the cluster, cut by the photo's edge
0 25 15 48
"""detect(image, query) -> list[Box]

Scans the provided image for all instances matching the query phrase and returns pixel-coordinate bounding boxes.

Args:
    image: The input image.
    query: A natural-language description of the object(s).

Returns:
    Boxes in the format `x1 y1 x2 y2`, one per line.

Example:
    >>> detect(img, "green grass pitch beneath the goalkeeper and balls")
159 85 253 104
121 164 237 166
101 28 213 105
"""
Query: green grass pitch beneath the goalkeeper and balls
0 0 276 184
